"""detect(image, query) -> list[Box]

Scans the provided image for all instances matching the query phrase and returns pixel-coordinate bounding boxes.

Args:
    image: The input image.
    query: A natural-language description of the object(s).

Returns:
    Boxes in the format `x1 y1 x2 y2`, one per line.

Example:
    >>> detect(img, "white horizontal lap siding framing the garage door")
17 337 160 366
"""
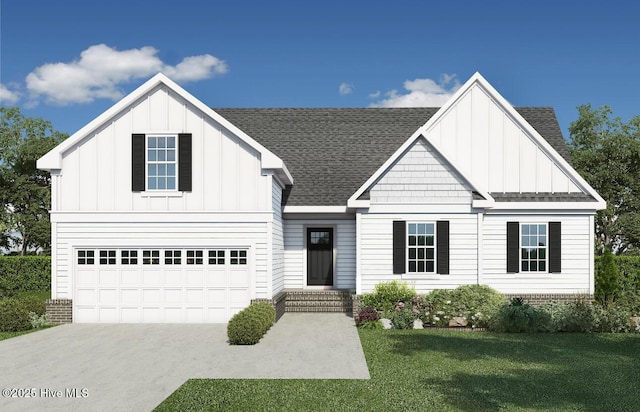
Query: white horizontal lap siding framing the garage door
53 222 270 299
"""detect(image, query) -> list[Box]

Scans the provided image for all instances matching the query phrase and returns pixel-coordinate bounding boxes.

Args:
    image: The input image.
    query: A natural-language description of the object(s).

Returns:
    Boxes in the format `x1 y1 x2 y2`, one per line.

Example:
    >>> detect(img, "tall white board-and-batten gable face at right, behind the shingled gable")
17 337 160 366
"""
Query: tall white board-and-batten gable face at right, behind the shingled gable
423 82 583 193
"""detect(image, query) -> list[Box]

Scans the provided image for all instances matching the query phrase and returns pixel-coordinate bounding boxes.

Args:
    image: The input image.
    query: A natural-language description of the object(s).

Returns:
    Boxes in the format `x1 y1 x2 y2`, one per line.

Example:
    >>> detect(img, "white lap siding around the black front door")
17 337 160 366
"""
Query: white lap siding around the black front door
284 220 356 289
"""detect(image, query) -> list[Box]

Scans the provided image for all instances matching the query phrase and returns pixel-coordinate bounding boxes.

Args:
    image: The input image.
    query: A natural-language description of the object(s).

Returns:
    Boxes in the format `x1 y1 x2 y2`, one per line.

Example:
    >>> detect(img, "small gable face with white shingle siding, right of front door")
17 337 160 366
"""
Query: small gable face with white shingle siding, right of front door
369 138 473 206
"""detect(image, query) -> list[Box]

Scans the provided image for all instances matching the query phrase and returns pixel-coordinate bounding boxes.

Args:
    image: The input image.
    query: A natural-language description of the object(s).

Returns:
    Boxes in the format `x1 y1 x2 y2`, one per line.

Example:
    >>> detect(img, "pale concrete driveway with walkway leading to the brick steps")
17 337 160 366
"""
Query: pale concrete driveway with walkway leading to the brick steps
0 313 369 411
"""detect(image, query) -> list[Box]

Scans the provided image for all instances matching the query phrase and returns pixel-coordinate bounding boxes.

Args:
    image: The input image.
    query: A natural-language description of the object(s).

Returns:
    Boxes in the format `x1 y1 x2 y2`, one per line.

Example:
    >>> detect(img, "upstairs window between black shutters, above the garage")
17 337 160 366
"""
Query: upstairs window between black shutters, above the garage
147 135 177 190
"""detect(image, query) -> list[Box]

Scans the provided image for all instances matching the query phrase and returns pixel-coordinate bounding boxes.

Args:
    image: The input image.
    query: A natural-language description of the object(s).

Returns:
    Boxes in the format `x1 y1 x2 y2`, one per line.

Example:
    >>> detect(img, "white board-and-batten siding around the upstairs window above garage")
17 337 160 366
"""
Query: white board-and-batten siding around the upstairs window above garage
52 83 271 212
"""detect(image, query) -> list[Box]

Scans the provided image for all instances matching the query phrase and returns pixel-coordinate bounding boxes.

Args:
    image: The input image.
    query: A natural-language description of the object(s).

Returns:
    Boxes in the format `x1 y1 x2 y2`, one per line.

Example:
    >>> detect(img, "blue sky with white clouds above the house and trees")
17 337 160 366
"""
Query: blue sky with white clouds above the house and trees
0 0 640 137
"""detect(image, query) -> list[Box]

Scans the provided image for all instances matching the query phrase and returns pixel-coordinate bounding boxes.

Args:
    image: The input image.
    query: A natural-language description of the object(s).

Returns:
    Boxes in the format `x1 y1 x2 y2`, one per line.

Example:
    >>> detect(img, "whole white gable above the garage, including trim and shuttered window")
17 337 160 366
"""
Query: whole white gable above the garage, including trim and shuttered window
38 75 291 212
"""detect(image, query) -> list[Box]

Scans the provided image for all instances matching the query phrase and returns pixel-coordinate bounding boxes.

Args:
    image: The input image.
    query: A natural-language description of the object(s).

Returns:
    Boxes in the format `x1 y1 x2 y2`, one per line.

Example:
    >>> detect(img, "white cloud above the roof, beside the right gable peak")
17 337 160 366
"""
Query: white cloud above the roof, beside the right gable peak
369 73 460 107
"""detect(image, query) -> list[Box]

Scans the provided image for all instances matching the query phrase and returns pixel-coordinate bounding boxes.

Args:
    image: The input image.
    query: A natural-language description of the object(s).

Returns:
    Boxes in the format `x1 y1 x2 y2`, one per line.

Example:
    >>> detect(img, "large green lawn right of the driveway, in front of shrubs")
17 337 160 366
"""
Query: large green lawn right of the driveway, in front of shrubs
156 330 640 411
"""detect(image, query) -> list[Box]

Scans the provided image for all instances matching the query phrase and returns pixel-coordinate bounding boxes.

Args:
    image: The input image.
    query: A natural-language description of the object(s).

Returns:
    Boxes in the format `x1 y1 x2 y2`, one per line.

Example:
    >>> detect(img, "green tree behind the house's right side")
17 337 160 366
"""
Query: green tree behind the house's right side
569 104 640 254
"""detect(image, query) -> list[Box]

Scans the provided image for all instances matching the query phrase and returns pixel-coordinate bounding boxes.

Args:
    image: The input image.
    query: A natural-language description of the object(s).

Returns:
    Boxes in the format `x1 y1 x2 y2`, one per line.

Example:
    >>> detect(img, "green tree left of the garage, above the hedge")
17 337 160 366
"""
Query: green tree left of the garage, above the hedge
0 107 67 255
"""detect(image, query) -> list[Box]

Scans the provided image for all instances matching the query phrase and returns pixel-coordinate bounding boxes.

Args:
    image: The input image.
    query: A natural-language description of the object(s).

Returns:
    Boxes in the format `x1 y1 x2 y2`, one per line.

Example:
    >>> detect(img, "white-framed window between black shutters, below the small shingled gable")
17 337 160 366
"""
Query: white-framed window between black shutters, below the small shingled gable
407 223 436 273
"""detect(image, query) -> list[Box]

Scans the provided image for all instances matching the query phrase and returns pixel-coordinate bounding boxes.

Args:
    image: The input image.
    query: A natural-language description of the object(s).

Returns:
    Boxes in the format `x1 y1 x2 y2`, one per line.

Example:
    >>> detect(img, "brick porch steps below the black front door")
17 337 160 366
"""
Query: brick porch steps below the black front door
285 290 353 314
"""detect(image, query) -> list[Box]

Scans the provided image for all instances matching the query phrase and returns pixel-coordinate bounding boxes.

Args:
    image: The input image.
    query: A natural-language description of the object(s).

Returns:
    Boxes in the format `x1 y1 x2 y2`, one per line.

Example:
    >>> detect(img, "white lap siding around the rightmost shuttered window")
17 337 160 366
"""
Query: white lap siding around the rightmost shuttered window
482 215 593 293
